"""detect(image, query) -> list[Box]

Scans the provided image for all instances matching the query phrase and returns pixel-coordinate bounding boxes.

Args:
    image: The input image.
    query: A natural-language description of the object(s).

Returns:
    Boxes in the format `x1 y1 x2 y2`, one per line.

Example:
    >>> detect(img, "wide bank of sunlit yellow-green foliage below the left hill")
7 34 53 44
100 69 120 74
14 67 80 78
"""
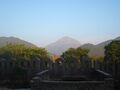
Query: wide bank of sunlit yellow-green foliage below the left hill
0 44 49 60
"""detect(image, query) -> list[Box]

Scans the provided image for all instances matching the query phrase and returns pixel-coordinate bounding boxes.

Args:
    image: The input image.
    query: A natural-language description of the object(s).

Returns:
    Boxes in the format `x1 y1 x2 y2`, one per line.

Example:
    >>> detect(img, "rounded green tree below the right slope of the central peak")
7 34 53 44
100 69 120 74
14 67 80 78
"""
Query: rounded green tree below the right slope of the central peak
62 48 89 71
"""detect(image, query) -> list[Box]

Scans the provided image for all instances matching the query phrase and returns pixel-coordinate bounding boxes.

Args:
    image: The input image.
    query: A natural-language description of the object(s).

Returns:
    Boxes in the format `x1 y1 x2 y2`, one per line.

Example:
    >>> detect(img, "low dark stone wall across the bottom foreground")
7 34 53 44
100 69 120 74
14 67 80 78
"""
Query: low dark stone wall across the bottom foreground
31 71 114 90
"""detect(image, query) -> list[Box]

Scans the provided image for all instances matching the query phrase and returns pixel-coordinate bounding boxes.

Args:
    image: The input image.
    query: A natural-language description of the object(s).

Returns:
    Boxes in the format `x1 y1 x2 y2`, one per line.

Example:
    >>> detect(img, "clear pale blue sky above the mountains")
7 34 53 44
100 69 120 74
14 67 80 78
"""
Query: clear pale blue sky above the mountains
0 0 120 46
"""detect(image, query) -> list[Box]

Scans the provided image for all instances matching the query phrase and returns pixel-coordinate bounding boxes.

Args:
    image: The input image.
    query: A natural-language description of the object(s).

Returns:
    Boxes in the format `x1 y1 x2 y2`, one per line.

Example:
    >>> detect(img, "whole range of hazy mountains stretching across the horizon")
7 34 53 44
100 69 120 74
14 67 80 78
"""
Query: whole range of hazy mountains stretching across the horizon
0 37 120 56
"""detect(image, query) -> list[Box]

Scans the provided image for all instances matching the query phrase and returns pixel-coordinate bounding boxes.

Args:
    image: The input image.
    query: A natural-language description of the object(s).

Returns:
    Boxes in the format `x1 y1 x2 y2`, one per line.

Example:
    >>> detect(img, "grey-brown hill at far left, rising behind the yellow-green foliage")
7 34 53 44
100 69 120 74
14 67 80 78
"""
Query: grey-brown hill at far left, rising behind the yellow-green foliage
0 37 36 47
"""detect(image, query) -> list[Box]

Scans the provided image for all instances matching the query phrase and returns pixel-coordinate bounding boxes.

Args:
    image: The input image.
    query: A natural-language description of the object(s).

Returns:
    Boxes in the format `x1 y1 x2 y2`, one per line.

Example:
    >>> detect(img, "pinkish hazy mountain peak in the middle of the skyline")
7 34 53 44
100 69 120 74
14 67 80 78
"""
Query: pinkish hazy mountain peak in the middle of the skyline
46 37 80 55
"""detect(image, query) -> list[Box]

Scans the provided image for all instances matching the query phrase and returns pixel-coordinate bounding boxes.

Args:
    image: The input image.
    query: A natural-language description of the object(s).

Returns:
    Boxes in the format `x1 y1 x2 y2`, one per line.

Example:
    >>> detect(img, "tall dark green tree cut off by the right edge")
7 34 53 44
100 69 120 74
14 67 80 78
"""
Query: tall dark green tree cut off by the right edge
104 40 120 82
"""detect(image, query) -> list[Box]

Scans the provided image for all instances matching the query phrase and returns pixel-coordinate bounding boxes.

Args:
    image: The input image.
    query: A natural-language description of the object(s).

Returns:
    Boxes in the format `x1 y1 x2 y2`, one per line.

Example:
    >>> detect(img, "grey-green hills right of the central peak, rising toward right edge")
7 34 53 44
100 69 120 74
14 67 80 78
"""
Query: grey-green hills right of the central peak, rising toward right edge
81 37 120 56
